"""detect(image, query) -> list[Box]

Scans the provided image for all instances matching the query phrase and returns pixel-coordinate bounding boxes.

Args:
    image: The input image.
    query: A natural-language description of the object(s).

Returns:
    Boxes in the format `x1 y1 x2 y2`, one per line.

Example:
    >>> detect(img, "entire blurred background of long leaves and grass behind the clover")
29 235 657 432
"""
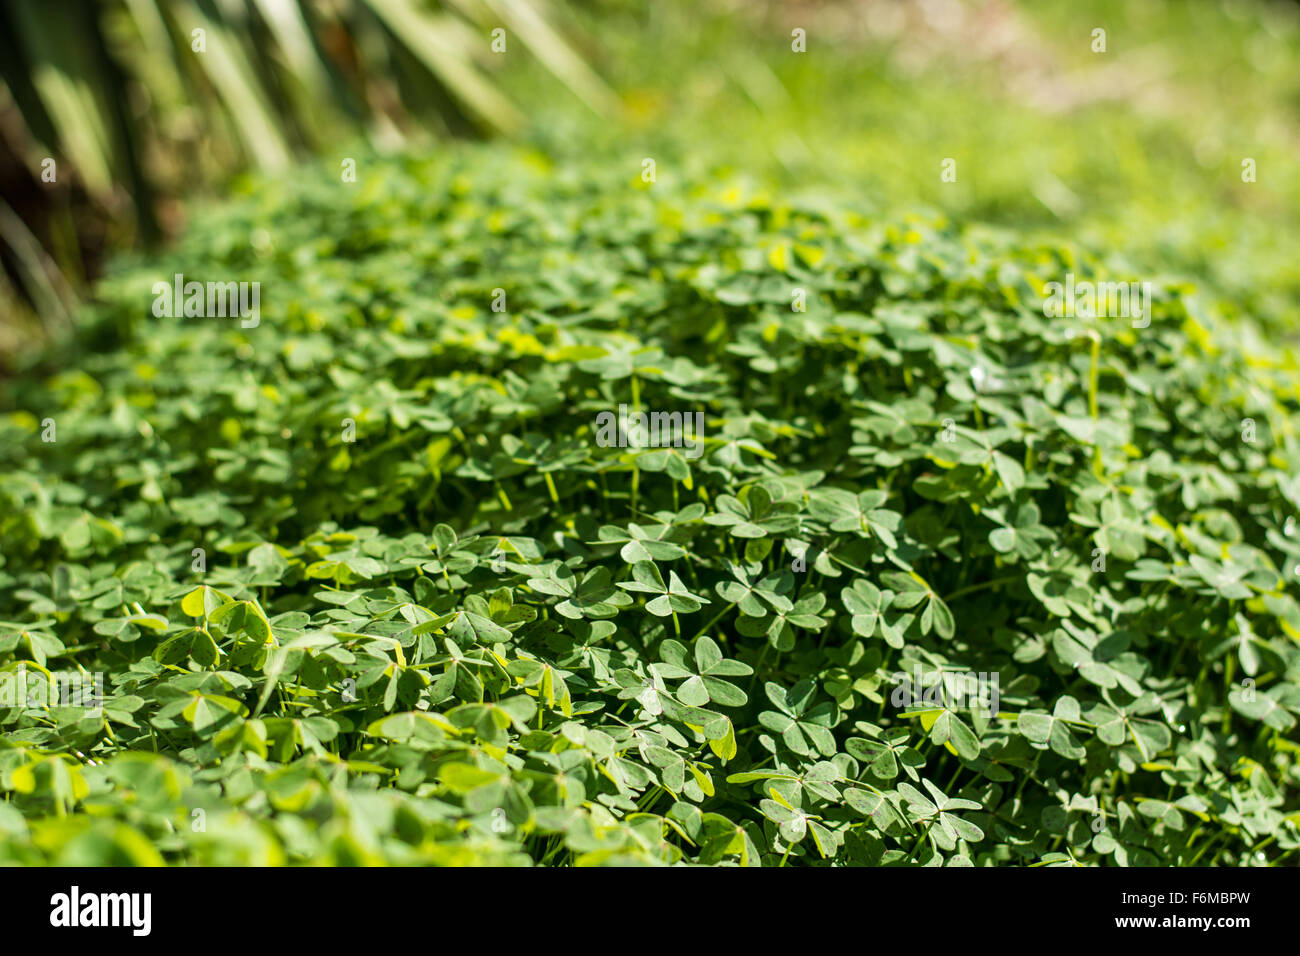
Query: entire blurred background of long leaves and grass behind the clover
0 0 1300 364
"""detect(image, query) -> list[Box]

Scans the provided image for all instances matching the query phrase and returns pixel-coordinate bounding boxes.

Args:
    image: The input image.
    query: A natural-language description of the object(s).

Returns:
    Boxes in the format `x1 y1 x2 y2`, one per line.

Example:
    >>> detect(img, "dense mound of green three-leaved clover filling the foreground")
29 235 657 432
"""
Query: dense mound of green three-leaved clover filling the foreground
0 148 1300 865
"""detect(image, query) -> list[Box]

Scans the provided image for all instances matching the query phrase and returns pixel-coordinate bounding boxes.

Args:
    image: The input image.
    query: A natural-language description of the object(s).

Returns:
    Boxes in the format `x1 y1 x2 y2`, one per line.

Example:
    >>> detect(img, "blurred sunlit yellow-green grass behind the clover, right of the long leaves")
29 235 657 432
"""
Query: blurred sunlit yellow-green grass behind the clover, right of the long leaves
506 0 1300 333
